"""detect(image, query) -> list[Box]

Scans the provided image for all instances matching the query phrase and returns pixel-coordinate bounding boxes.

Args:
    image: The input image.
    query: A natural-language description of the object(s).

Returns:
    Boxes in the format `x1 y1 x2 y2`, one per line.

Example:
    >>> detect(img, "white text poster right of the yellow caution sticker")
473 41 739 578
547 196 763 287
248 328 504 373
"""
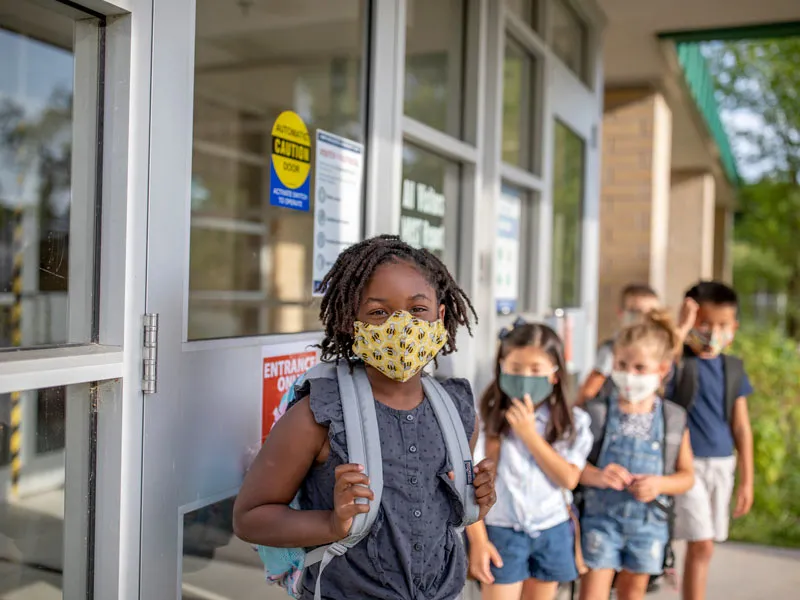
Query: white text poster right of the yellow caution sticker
312 129 364 296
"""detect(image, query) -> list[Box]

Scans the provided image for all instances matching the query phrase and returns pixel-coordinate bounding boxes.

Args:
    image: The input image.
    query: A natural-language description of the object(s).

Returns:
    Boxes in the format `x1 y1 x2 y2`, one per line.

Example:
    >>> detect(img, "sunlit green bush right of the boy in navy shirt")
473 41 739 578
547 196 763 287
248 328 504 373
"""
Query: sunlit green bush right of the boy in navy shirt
731 331 800 547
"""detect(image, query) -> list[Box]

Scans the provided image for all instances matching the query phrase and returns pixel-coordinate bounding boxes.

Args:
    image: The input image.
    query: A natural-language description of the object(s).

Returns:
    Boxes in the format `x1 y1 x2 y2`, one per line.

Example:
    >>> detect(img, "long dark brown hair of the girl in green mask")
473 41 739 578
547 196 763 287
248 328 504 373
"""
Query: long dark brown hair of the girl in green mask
480 323 575 444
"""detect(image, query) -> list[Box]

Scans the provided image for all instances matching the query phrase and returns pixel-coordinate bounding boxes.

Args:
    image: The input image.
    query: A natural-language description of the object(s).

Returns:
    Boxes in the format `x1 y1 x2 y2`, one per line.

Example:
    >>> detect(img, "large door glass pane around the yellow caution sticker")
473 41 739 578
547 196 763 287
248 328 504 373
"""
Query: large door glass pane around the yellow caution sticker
189 0 366 339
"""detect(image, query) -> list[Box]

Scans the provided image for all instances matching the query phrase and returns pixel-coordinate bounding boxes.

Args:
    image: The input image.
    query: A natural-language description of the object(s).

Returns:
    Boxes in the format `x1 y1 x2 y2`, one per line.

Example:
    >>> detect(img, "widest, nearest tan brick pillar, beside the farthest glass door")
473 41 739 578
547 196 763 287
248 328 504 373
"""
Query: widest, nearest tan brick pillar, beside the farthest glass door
598 88 672 339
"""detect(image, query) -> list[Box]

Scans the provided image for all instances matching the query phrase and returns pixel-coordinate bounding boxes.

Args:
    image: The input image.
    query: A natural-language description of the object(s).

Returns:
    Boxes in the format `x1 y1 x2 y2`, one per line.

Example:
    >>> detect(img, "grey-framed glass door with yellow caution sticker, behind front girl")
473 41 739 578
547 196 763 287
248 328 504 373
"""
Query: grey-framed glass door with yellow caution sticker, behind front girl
140 0 367 599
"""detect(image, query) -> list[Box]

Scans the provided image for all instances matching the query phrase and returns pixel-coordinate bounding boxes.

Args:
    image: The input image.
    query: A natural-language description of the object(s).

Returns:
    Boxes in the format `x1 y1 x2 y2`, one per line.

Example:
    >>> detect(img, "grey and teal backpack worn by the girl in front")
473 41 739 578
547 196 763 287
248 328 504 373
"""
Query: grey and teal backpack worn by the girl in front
257 361 480 600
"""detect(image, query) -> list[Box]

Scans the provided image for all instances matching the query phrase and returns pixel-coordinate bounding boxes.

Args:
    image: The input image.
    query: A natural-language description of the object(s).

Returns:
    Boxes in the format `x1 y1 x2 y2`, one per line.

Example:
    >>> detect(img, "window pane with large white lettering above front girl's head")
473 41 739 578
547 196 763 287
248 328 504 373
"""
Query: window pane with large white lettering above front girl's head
400 144 461 262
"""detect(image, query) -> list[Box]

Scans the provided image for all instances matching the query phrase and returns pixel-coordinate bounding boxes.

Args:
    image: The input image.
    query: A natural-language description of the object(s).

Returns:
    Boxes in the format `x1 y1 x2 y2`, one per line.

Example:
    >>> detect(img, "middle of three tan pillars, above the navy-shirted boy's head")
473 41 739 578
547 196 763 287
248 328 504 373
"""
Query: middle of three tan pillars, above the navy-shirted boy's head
664 171 716 309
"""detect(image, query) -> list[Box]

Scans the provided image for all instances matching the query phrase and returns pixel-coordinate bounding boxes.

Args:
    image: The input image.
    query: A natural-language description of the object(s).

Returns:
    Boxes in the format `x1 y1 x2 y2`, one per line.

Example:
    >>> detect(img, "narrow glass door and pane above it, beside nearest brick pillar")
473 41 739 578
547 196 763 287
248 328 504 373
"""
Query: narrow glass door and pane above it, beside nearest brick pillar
545 0 602 375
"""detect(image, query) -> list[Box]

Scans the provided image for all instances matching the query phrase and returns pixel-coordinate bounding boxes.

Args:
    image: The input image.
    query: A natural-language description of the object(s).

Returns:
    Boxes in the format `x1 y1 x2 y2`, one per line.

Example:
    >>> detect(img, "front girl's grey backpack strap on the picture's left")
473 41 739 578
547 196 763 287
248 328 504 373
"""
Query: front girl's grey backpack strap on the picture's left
305 360 383 600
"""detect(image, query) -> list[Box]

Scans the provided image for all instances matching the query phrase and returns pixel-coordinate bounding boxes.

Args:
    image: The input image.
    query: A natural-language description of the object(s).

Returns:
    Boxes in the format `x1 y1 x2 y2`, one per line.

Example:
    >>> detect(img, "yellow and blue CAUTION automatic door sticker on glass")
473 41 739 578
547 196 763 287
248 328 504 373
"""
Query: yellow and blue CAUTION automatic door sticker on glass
269 110 311 212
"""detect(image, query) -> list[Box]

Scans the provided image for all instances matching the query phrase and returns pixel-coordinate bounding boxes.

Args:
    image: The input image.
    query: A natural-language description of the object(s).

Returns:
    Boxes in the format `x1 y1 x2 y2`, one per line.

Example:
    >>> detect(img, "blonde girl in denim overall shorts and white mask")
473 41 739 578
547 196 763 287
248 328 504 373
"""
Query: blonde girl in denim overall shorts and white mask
581 311 694 600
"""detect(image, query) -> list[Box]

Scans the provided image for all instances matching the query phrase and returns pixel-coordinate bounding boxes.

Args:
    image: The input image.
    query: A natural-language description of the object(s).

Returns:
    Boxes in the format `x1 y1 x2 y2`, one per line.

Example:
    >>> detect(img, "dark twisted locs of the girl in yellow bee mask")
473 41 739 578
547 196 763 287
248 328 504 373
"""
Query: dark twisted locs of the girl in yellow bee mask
319 235 478 361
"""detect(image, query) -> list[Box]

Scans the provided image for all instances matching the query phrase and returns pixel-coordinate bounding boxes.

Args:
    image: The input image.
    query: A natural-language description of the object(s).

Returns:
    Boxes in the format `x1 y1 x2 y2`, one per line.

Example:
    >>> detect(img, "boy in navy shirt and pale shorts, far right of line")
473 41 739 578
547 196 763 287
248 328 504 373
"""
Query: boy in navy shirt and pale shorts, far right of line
675 281 753 600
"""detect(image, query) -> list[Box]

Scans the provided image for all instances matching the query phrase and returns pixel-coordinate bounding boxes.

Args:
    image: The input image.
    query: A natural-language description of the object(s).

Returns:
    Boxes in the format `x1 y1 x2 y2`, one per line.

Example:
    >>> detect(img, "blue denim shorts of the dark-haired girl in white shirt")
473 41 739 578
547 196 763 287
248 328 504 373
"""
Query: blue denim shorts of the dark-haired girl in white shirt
486 521 578 584
